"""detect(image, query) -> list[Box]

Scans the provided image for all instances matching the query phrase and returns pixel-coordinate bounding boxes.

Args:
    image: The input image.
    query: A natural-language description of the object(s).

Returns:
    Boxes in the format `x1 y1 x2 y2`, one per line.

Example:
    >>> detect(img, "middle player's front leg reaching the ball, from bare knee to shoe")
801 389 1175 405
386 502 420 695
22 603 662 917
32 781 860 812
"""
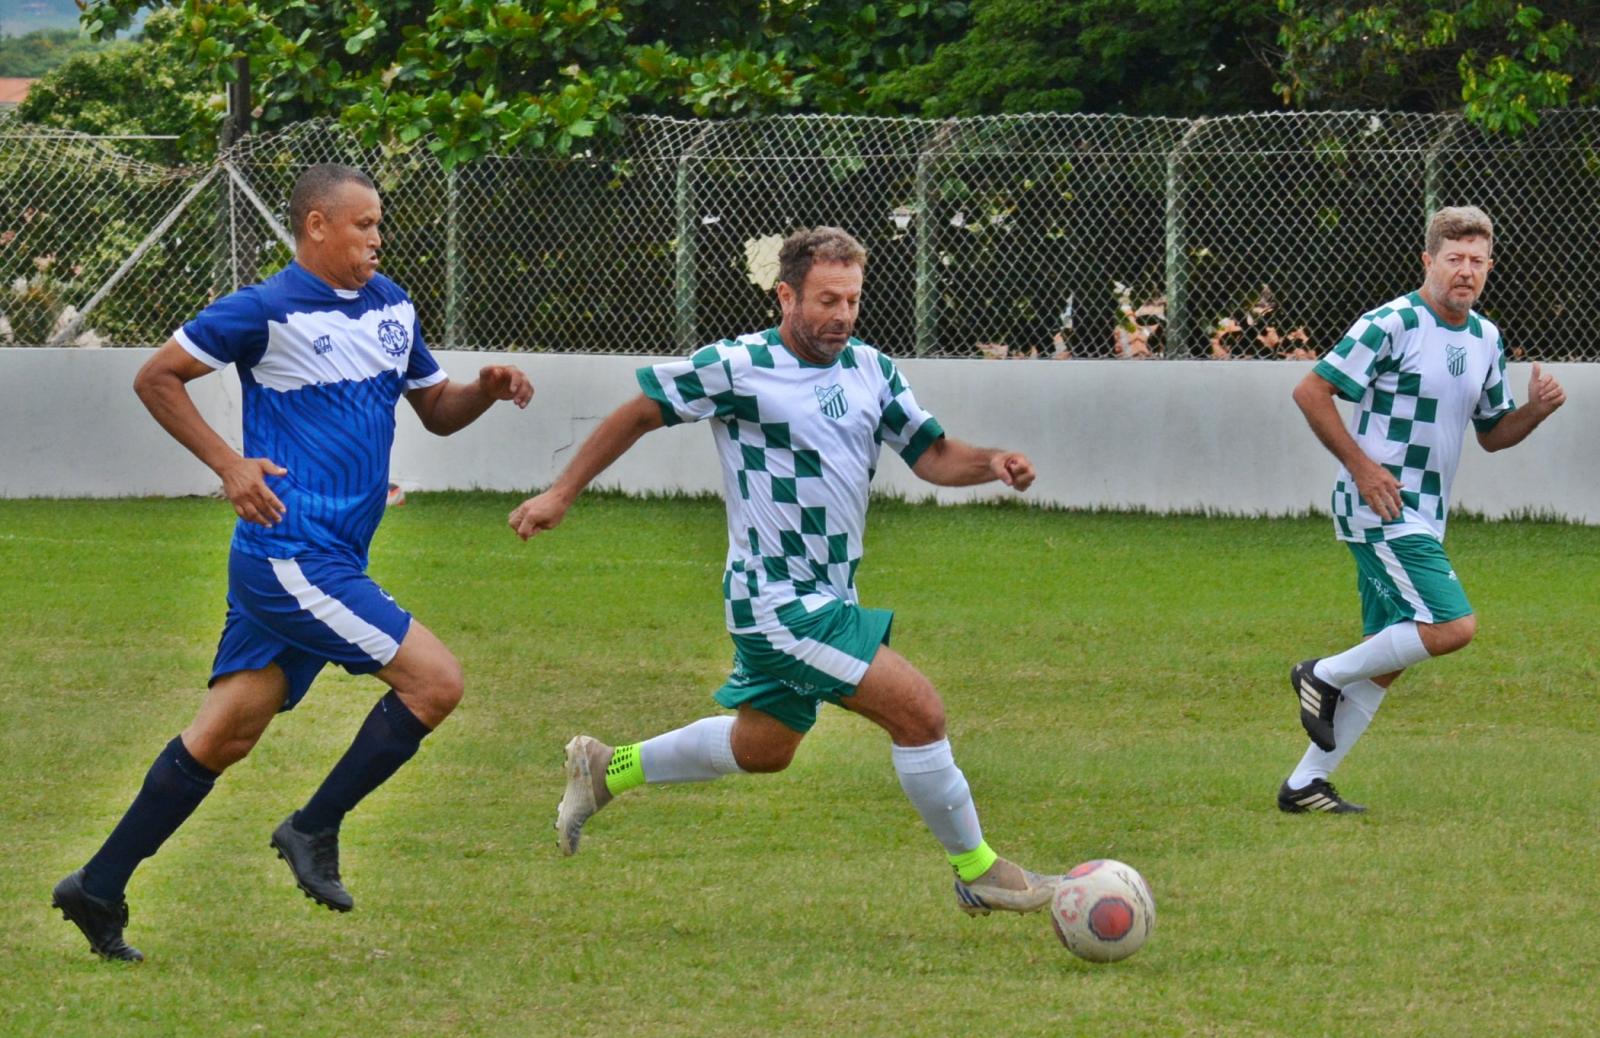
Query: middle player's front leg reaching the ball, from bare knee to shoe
840 646 1058 915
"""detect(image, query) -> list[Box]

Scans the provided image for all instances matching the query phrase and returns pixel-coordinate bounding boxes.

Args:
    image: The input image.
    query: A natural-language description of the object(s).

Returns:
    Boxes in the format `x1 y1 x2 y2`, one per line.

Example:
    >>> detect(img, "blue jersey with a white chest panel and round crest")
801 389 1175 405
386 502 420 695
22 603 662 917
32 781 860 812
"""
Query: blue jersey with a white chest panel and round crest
173 262 446 565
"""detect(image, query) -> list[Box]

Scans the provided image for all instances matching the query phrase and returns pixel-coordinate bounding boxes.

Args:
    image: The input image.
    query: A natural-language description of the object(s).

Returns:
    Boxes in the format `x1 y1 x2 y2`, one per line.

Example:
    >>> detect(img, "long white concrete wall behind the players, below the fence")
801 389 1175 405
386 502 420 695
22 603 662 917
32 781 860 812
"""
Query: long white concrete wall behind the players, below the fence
0 349 1600 523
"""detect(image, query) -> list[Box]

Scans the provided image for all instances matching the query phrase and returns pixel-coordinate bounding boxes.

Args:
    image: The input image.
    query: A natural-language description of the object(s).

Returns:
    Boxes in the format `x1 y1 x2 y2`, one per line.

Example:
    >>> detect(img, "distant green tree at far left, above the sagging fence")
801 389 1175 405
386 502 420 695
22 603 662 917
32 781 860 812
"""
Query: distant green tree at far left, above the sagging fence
18 11 222 162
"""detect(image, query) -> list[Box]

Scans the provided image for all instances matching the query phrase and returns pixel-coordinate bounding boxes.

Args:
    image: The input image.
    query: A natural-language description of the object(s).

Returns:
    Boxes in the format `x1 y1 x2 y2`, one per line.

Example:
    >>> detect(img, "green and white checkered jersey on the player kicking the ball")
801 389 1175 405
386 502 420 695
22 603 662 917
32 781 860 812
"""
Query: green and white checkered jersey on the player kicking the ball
638 328 944 633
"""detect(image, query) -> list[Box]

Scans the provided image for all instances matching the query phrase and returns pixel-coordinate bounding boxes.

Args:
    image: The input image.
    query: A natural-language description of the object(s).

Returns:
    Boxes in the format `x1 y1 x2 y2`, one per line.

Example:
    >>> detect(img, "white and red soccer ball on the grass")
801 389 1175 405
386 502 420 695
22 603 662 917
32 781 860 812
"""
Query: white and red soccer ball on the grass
1050 859 1155 963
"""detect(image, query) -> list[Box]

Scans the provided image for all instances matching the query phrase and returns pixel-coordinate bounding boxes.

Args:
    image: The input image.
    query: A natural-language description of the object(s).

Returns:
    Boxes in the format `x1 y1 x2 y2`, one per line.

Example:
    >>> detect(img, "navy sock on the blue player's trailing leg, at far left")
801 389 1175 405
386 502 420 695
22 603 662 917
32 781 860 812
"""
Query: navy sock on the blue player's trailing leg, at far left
83 736 216 900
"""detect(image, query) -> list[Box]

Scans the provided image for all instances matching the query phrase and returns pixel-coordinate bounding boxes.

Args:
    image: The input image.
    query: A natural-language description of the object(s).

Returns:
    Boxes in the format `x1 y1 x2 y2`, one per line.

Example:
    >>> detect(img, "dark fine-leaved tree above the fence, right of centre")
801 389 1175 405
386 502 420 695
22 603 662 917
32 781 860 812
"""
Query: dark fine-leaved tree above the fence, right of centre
875 0 1277 117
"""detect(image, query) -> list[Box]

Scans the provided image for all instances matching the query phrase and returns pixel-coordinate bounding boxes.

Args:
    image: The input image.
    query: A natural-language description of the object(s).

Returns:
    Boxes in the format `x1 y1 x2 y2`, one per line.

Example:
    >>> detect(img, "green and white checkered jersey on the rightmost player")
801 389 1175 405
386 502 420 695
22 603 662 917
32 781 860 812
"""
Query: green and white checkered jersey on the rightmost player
1315 293 1517 542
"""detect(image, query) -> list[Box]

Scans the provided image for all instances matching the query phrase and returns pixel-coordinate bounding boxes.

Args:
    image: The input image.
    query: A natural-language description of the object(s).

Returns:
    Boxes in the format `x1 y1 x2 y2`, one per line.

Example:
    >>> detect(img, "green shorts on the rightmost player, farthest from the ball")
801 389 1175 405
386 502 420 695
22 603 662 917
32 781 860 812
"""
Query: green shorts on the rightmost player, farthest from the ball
1346 534 1472 635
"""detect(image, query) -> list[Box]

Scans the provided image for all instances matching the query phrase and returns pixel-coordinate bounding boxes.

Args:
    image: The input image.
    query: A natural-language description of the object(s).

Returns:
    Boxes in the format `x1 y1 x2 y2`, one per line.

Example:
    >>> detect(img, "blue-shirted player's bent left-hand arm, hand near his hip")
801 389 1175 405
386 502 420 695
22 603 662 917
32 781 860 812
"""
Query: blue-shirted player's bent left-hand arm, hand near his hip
133 339 288 526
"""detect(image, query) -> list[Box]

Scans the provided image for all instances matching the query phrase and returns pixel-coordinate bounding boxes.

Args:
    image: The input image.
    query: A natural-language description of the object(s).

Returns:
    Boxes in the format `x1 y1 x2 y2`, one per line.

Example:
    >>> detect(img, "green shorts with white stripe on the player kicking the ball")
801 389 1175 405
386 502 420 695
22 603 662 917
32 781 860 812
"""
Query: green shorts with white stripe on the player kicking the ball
715 601 894 733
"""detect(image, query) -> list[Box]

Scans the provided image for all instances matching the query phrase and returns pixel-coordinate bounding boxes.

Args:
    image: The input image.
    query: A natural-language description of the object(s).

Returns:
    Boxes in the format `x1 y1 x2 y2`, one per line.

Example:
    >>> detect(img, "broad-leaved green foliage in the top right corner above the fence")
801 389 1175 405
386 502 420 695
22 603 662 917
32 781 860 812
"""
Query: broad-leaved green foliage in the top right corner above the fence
1278 0 1600 133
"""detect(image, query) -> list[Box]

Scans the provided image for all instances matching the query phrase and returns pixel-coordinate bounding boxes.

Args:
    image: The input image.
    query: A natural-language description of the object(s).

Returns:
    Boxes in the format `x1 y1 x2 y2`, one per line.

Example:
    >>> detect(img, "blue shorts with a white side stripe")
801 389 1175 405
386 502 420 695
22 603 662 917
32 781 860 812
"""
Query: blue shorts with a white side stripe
211 552 411 710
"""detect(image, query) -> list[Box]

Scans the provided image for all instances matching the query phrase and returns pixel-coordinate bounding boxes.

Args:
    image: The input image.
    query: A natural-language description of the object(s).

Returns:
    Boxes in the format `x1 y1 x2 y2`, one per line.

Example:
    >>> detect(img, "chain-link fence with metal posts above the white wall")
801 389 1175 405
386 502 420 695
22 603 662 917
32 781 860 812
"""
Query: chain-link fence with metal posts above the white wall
0 110 1600 360
